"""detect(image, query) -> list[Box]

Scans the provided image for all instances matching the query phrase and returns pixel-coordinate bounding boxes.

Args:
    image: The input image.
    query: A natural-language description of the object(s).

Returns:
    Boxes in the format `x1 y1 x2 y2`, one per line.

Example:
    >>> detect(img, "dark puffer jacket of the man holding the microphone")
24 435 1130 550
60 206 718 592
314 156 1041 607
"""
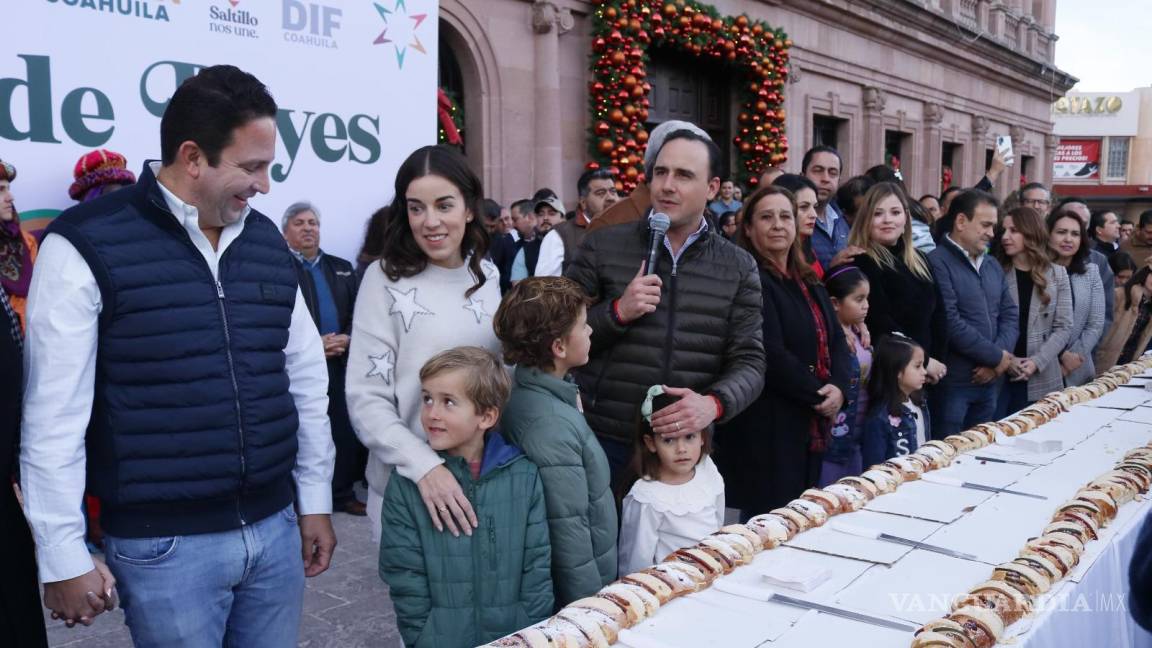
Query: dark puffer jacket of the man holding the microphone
566 220 765 443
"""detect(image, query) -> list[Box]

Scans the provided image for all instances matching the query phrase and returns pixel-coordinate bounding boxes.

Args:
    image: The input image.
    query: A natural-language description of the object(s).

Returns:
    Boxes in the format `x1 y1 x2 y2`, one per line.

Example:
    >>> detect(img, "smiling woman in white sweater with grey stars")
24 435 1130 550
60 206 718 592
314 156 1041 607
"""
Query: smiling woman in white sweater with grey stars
346 146 500 542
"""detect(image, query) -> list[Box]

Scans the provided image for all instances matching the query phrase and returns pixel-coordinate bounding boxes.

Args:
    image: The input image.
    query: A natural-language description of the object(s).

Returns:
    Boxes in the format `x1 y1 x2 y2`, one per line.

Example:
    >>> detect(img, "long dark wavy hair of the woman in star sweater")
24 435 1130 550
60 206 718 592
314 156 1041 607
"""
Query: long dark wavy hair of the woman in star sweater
375 145 488 296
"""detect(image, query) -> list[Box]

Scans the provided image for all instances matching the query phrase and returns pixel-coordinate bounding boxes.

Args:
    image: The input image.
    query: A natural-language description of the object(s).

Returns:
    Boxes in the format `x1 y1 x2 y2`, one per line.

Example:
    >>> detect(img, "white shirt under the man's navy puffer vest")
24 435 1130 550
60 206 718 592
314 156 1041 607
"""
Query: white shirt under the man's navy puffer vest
20 164 335 582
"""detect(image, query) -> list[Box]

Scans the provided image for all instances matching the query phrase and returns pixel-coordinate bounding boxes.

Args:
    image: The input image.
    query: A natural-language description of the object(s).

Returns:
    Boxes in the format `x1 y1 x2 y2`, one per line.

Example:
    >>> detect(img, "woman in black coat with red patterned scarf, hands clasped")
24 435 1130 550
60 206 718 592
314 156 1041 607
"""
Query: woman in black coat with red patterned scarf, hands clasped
715 186 851 519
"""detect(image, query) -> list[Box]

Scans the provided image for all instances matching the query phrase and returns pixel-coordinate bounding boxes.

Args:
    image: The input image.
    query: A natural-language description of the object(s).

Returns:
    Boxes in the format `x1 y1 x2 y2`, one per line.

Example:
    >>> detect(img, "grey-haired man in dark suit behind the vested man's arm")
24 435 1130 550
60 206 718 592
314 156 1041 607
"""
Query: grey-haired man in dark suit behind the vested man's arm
280 202 367 515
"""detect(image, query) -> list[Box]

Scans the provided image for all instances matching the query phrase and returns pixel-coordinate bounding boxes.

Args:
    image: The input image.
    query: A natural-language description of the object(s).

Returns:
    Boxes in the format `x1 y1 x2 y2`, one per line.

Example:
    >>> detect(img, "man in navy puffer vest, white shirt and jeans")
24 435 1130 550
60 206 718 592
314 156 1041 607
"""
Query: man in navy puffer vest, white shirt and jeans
21 66 336 648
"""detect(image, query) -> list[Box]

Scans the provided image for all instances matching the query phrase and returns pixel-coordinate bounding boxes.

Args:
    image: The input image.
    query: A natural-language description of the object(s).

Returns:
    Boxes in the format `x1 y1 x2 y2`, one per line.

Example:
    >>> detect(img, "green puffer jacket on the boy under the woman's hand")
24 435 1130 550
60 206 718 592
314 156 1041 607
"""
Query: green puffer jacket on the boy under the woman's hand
380 432 553 648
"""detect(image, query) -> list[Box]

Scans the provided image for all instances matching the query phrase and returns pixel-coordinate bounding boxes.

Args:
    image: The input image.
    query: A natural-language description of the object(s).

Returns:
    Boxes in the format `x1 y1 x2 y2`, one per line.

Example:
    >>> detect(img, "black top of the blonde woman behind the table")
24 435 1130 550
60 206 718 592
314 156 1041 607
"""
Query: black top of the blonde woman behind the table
852 242 948 362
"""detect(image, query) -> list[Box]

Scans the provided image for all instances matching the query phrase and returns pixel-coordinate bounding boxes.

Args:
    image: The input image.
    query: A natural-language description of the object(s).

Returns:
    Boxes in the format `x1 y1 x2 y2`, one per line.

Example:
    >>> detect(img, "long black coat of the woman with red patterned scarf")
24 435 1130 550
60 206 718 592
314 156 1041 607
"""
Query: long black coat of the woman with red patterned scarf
715 270 852 513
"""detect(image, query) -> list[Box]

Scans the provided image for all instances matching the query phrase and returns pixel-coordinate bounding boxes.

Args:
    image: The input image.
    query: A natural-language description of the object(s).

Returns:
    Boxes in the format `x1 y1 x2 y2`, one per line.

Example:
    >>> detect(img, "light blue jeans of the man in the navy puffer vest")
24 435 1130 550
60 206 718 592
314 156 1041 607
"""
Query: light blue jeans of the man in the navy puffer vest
105 506 304 648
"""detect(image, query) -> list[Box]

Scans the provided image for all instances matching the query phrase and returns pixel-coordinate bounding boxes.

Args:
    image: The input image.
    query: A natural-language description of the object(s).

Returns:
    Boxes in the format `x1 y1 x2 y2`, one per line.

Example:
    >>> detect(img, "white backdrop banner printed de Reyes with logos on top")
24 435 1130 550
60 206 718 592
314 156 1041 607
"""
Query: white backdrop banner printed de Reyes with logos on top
0 0 438 258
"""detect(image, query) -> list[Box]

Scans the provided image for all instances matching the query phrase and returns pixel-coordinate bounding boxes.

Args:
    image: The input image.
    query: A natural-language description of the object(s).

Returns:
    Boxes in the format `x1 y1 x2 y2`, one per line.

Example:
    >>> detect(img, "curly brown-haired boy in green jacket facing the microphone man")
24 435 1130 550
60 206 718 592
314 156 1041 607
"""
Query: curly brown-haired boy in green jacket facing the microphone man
493 277 620 606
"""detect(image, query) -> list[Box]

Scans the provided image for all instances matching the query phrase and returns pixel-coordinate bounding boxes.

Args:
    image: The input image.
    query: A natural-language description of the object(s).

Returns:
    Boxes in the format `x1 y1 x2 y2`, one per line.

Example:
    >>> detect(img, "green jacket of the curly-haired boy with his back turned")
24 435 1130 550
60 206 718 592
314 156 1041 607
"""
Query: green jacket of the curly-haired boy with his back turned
501 367 619 606
